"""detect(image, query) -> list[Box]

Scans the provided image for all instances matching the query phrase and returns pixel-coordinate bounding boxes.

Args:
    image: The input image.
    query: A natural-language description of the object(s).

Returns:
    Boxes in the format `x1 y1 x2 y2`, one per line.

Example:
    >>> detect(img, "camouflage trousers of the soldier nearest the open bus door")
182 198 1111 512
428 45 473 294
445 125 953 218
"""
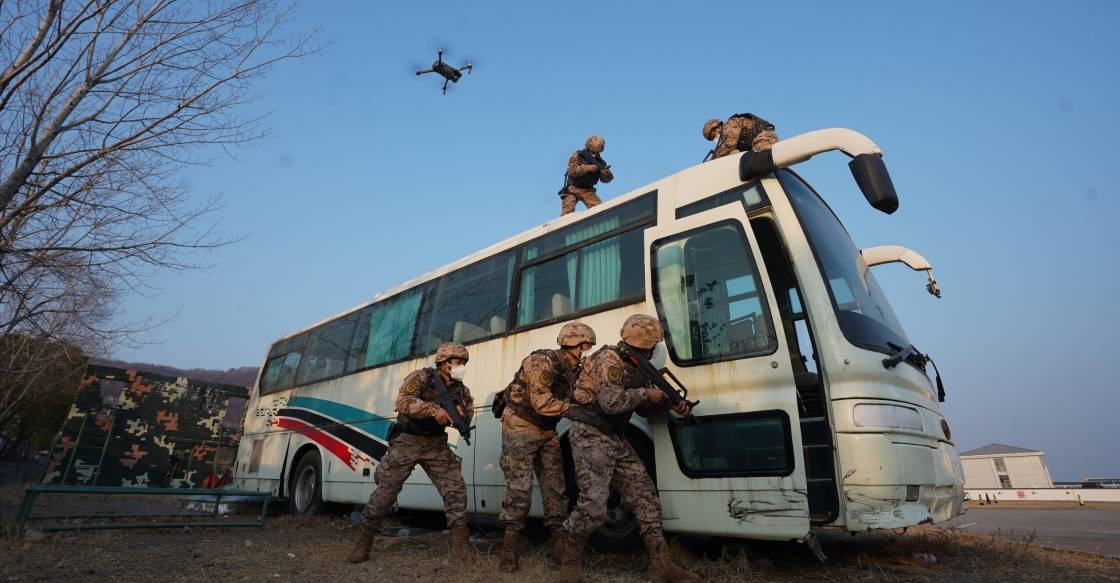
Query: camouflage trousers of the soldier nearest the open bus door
563 422 664 539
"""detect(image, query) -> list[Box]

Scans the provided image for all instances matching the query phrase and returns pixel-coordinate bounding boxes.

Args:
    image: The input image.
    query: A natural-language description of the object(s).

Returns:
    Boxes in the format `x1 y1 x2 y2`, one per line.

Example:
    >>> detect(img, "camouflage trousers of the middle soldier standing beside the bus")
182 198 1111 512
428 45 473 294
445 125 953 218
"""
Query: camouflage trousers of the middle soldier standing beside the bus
500 408 568 530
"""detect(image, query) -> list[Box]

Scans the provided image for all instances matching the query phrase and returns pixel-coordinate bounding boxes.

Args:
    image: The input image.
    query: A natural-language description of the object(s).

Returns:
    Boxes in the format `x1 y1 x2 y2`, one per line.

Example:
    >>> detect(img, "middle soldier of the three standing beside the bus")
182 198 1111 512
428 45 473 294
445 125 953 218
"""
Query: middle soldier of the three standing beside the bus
498 322 595 572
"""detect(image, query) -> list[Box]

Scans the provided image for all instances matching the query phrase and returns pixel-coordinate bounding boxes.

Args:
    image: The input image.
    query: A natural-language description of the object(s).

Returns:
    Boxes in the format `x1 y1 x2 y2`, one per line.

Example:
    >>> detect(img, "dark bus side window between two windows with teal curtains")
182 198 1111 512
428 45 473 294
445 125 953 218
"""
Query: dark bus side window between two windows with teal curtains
417 252 516 354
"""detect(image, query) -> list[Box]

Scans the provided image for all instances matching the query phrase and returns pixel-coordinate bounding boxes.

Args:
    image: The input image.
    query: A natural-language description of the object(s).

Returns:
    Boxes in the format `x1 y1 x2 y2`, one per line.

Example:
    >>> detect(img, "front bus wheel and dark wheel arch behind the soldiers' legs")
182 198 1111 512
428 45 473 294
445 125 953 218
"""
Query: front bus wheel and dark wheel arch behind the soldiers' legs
561 426 657 551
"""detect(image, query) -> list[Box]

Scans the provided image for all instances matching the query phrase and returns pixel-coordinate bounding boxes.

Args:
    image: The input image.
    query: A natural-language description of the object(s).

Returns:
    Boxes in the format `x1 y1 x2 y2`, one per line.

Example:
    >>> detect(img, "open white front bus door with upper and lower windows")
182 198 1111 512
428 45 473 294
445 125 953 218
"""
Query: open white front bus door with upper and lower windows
645 204 810 540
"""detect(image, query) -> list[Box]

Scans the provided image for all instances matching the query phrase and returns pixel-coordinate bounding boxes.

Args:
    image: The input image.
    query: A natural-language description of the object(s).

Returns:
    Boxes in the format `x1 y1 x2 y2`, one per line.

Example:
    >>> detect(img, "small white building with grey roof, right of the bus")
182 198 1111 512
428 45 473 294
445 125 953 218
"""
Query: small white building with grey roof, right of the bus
961 443 1054 490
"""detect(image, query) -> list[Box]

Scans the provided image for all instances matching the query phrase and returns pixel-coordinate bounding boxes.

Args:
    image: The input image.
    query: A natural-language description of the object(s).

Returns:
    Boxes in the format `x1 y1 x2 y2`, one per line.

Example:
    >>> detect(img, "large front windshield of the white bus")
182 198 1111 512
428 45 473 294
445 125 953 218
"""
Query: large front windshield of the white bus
777 170 909 354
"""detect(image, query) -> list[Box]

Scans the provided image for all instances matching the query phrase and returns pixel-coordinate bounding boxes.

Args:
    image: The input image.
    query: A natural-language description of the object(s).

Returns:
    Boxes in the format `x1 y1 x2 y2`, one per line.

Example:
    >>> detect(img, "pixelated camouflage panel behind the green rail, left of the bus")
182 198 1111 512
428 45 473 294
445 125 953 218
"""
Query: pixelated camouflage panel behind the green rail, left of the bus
43 365 249 488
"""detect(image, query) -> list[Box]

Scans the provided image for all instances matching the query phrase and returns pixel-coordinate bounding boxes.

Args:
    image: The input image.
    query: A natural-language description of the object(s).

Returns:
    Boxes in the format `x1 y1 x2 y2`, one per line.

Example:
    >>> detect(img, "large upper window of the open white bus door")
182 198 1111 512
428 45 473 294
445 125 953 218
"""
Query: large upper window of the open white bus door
654 223 777 364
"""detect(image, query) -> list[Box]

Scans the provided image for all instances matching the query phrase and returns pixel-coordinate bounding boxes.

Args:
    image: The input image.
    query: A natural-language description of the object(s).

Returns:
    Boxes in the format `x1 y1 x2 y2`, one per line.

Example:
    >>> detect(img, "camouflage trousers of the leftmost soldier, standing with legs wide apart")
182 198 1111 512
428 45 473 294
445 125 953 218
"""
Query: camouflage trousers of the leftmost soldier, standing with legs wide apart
362 433 467 528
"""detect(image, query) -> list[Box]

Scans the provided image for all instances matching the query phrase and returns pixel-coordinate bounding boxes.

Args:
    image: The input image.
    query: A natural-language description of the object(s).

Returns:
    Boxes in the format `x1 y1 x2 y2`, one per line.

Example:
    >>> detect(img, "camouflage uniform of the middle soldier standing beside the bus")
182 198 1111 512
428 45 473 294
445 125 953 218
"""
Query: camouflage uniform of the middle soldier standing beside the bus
500 350 571 530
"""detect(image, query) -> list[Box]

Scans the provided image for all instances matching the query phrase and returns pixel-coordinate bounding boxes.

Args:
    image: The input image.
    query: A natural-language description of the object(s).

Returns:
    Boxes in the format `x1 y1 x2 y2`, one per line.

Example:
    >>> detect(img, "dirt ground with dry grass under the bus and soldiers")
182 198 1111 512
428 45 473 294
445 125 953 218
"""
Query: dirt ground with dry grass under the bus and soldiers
0 489 1120 583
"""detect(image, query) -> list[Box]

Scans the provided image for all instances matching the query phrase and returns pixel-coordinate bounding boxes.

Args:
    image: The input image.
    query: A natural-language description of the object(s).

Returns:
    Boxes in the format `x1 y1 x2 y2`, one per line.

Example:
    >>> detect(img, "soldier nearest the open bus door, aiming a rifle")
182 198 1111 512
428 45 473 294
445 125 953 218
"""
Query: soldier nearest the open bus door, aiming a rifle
560 313 700 583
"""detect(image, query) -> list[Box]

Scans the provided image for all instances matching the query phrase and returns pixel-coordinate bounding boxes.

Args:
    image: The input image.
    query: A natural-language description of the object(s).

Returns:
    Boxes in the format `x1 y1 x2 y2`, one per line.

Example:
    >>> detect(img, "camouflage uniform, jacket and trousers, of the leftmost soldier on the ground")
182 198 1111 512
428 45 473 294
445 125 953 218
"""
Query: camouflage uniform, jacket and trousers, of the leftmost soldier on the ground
362 368 474 530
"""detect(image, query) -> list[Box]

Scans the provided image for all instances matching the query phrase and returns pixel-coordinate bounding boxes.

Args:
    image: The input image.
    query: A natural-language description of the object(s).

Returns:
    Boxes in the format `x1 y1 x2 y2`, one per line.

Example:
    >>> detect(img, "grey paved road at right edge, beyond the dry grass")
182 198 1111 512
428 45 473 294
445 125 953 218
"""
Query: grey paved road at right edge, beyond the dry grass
941 506 1120 557
